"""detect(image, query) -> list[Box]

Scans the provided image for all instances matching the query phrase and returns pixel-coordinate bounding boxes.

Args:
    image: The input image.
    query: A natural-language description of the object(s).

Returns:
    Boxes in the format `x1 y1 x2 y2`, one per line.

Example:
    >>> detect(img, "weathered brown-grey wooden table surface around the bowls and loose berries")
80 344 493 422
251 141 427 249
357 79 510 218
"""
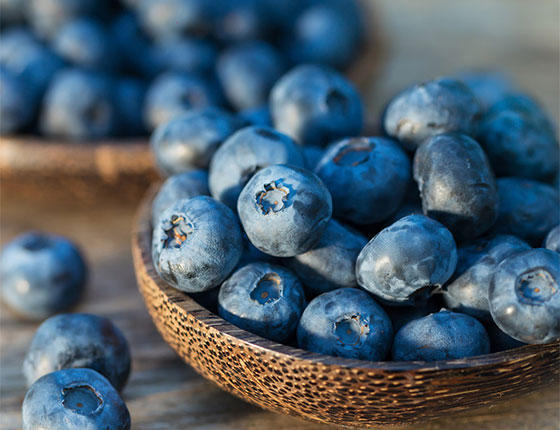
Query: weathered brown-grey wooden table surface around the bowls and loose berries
0 0 560 430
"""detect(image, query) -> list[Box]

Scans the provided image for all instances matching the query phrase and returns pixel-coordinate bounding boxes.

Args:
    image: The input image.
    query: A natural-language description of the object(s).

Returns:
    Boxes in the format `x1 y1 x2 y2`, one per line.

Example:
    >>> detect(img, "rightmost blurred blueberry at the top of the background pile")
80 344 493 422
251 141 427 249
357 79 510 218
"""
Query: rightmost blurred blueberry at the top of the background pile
287 0 364 69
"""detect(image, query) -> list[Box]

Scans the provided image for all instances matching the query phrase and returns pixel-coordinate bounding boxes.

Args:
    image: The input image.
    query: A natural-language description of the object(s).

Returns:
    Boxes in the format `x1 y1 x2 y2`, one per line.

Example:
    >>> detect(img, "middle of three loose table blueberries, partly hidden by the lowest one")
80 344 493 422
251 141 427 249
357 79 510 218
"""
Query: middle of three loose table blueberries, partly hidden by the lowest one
23 314 130 391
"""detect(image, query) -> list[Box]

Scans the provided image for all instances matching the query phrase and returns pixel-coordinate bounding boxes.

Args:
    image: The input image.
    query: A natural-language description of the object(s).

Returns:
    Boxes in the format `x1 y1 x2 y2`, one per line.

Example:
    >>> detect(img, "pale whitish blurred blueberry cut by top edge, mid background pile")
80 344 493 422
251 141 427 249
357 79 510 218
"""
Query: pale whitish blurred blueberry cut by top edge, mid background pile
136 0 219 40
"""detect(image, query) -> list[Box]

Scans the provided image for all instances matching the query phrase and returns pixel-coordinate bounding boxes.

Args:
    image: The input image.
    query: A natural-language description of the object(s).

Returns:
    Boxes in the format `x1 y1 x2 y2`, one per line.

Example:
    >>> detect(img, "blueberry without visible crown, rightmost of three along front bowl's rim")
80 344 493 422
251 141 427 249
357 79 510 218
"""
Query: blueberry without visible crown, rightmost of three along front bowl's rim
393 310 490 361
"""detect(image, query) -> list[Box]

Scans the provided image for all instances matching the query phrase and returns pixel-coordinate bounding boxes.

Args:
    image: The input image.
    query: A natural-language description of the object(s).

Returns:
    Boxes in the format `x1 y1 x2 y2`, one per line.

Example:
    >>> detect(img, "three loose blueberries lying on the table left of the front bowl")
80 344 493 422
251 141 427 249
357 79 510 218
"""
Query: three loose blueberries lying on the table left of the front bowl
0 232 131 430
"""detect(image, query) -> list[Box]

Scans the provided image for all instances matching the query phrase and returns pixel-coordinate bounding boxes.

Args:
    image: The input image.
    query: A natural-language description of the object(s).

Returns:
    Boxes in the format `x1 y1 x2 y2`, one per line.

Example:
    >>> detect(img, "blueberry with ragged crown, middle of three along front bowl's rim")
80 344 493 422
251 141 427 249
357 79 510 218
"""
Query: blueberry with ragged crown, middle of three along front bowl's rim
297 288 393 361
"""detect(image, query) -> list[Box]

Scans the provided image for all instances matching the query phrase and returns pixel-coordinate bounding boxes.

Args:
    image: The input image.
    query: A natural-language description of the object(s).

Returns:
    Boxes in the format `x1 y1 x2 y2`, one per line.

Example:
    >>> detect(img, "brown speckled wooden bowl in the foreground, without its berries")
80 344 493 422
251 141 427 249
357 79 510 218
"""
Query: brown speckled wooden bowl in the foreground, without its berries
132 187 560 427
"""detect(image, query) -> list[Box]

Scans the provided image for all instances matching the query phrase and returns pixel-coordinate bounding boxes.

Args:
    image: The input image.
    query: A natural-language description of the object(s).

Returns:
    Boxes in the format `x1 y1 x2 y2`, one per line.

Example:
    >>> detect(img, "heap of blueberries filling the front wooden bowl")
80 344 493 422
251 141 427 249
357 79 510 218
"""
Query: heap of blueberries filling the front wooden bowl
151 64 560 361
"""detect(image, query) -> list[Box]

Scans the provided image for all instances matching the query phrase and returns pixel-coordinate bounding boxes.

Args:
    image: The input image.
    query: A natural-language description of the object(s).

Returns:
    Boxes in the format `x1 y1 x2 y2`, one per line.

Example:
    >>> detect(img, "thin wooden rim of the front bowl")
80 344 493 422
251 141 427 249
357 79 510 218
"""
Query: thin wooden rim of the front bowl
132 183 560 372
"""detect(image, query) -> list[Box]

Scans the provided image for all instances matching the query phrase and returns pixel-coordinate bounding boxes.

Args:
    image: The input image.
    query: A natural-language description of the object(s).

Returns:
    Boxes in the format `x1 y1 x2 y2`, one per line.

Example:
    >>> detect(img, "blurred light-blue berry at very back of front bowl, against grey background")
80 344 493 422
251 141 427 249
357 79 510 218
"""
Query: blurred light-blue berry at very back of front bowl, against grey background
457 70 513 111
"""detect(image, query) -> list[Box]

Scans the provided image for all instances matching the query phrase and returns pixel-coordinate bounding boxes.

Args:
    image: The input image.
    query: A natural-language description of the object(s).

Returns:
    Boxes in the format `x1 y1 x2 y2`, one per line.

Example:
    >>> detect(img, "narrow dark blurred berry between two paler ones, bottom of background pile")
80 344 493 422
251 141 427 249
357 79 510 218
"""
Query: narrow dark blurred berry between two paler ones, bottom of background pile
115 77 146 136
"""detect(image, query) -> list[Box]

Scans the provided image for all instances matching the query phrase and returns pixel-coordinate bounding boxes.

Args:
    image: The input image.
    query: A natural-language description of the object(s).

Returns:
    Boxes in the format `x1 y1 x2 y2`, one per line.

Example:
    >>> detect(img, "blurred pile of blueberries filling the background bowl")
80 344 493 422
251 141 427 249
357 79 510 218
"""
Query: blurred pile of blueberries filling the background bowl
0 0 364 140
